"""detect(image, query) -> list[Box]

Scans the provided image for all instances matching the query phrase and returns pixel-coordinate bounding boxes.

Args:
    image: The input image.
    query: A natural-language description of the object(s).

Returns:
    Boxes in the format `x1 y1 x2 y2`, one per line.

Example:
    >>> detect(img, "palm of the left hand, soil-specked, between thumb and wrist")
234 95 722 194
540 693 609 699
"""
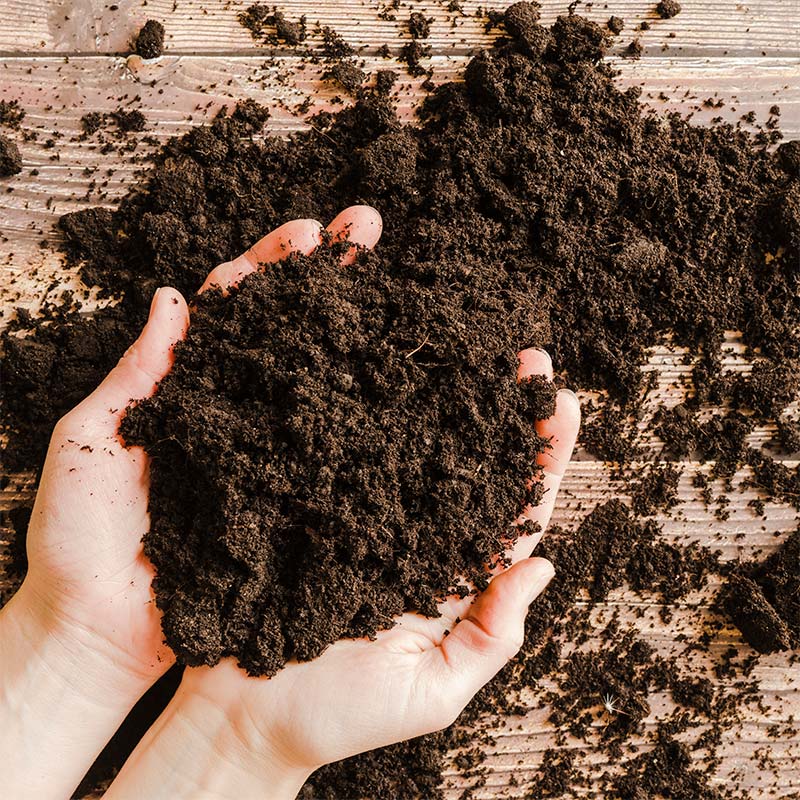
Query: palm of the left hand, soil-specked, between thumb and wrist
28 406 172 675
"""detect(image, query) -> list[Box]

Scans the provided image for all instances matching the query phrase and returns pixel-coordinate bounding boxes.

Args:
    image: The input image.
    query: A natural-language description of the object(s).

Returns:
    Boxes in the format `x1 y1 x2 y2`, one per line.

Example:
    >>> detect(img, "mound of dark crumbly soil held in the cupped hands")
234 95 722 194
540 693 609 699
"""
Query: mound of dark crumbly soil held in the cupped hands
121 246 554 675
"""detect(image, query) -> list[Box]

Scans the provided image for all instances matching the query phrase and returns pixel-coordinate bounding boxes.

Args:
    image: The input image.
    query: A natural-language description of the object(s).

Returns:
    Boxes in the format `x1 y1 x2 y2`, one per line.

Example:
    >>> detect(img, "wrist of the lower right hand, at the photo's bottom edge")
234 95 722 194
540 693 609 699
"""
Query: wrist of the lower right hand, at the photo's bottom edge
105 669 312 800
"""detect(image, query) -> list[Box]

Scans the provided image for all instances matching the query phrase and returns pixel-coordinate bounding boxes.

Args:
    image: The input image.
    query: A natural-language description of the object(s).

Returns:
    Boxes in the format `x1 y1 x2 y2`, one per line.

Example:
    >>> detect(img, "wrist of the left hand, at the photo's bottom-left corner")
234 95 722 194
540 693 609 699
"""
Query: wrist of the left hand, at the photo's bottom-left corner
0 584 155 800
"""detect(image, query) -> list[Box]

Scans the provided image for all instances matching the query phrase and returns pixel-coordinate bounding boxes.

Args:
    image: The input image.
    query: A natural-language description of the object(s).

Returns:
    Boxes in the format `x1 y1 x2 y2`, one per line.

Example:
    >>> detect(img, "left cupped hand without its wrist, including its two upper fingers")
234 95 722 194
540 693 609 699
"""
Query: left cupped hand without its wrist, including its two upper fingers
21 208 380 685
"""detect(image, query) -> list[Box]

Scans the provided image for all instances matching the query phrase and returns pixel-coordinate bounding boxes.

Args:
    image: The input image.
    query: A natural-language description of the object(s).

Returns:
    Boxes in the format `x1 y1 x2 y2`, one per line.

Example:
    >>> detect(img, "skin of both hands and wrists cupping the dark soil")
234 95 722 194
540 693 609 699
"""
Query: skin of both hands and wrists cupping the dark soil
0 206 580 800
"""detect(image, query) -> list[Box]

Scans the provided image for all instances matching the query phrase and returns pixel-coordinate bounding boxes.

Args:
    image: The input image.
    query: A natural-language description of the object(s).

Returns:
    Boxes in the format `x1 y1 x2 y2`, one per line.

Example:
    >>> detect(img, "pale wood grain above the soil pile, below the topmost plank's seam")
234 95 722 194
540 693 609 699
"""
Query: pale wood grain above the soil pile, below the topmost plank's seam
0 56 800 318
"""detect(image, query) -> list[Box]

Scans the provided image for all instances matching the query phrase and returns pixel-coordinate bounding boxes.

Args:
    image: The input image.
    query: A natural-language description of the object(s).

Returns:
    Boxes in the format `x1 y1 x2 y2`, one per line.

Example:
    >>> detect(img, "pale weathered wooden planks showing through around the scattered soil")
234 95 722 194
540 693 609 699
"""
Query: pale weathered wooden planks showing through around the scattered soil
0 0 800 798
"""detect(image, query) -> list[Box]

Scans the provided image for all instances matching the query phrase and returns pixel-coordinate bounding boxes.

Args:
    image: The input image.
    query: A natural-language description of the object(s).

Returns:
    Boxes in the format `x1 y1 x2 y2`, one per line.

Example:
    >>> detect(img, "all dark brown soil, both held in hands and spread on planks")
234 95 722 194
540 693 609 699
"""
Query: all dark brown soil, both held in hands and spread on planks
3 3 800 800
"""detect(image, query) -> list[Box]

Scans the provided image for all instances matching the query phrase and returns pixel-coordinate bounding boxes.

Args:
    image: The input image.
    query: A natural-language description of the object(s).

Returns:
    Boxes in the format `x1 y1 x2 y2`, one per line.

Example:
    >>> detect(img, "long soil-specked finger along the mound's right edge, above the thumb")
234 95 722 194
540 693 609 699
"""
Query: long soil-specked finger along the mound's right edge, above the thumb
507 389 581 563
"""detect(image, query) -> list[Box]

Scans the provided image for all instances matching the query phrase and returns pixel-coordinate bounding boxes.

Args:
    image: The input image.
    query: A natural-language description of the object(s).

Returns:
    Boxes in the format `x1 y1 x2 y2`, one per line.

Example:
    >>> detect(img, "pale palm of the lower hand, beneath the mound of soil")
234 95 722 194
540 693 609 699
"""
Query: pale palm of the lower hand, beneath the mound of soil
184 598 472 768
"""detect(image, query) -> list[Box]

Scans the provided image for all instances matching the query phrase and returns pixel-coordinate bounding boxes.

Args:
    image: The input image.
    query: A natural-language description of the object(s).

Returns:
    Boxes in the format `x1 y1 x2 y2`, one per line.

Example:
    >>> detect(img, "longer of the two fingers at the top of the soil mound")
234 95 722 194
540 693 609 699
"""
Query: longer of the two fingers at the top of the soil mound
198 219 322 294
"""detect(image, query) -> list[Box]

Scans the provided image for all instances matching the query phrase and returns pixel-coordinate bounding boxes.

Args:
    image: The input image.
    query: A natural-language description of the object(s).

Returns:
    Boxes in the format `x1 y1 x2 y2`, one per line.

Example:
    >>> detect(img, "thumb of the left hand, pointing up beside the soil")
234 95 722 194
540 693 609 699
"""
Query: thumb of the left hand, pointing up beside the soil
67 287 189 433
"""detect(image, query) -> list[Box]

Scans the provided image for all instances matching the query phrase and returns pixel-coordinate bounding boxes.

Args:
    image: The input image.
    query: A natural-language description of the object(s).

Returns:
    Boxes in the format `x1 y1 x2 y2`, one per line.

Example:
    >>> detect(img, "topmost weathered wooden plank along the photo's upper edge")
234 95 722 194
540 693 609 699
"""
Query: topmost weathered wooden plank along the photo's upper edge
0 0 800 56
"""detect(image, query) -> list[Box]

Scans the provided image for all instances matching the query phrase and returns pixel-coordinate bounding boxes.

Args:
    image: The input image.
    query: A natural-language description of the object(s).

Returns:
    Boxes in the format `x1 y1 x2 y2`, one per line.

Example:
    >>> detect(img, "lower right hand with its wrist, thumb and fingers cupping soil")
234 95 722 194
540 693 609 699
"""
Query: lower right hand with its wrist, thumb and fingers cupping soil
107 203 580 798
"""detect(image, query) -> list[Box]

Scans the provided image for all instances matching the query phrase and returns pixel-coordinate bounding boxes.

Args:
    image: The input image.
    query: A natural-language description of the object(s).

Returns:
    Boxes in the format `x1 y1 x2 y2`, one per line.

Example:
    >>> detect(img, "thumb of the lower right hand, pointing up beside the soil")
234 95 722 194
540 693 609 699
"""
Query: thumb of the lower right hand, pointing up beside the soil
428 558 553 712
